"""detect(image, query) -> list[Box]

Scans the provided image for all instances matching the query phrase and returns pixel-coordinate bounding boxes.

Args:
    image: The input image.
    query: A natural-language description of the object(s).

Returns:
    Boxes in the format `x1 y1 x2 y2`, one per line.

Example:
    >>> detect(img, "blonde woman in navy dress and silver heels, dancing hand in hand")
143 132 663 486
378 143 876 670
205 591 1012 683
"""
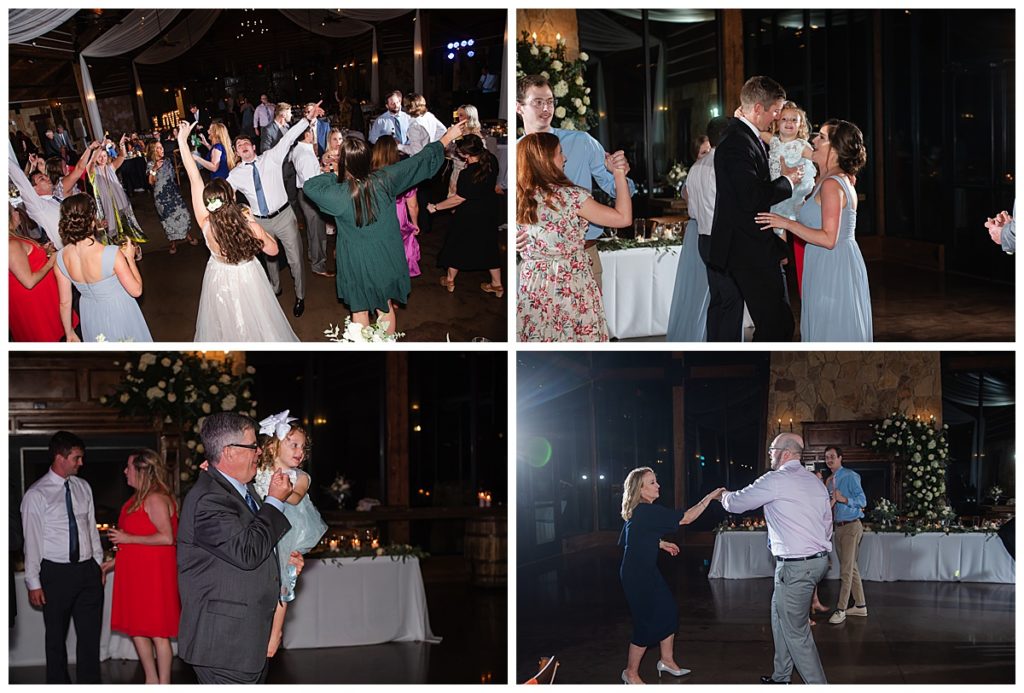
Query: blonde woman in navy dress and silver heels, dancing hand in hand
618 467 725 684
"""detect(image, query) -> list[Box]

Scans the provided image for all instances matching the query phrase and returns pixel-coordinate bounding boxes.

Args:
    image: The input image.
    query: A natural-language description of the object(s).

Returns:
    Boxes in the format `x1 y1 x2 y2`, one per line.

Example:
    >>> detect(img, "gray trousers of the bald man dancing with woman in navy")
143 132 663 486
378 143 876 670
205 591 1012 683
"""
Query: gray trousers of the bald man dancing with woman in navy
771 556 828 684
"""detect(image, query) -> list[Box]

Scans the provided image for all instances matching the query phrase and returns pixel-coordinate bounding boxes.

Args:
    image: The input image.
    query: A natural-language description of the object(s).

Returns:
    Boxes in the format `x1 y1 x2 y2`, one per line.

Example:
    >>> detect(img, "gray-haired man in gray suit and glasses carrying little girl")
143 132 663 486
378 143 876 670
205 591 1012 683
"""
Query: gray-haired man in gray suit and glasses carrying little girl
178 412 301 684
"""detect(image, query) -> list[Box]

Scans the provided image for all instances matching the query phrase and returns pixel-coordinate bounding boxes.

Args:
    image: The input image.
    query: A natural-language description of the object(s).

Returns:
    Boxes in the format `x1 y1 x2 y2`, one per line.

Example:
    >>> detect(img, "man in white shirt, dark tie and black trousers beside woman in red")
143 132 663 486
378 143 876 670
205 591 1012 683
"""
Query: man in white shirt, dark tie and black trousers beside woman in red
22 431 103 684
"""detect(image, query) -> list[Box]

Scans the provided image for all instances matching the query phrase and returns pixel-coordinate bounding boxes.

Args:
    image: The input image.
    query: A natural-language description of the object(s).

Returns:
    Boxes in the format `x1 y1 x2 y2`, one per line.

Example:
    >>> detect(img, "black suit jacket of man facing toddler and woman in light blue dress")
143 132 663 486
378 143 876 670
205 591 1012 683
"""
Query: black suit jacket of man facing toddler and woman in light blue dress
709 119 793 269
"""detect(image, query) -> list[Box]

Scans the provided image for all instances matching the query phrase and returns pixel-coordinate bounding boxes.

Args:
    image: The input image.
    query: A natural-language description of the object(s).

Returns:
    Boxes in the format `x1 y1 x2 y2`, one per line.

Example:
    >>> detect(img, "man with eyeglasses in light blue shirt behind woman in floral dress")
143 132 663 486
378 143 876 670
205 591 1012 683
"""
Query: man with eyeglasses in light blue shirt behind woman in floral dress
515 75 636 302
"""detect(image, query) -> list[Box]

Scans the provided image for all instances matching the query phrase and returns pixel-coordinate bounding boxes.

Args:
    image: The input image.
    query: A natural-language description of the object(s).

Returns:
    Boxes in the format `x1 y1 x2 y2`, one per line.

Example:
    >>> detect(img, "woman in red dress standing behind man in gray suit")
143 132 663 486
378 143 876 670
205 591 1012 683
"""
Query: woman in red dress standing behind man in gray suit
103 449 181 684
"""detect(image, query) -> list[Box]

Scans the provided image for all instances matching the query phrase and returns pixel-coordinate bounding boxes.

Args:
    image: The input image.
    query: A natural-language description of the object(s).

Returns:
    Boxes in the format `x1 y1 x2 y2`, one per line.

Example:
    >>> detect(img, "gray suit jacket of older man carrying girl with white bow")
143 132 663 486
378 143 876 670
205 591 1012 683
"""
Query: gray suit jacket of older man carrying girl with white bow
178 467 292 673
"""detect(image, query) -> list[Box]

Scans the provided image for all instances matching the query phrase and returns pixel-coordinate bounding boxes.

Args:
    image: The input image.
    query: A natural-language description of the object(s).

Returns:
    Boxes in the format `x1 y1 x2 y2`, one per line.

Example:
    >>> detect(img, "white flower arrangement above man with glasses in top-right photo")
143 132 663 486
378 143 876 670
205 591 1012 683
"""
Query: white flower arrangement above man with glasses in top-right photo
516 32 597 132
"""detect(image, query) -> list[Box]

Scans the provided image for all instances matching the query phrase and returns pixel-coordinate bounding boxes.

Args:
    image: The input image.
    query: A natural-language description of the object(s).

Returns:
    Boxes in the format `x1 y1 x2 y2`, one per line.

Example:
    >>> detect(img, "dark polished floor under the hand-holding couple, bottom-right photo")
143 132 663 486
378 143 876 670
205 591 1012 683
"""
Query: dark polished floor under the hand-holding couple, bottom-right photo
516 547 1016 685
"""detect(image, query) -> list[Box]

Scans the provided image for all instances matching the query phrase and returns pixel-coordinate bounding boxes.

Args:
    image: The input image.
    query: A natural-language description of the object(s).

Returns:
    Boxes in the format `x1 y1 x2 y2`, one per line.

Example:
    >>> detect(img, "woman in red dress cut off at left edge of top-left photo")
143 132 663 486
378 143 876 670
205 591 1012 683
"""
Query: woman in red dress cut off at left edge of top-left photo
7 207 78 342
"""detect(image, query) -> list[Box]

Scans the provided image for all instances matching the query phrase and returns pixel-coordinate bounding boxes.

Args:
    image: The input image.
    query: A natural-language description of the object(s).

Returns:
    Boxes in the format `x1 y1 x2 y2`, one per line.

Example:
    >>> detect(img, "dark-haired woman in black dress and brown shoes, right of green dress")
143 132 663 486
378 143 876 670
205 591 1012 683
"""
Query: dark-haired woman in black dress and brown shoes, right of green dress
427 135 505 298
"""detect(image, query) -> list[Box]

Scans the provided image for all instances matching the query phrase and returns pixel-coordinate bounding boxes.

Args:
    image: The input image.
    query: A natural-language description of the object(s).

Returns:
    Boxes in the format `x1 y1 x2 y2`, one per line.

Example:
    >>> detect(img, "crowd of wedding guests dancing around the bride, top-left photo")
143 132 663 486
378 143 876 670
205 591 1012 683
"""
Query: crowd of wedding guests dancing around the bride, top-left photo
8 91 504 342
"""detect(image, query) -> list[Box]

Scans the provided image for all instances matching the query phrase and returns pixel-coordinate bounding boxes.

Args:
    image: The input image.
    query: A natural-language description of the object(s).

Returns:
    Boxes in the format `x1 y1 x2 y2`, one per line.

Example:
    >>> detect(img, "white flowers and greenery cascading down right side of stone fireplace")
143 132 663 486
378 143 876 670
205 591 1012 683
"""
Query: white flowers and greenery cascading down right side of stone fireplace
865 412 949 520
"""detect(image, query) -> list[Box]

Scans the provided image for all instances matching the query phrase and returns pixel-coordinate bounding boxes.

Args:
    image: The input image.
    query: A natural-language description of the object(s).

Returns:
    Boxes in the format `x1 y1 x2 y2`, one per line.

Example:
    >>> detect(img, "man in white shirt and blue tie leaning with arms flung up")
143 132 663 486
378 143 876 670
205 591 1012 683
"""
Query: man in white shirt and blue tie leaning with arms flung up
227 103 319 317
